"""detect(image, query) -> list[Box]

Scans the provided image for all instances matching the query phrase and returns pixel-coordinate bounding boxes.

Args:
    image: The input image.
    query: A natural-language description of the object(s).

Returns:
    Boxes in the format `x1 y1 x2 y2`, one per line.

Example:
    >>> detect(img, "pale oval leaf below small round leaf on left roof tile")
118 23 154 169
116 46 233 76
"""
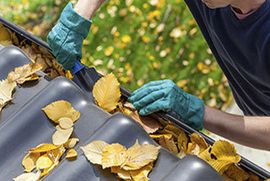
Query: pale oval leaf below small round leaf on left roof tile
52 127 73 145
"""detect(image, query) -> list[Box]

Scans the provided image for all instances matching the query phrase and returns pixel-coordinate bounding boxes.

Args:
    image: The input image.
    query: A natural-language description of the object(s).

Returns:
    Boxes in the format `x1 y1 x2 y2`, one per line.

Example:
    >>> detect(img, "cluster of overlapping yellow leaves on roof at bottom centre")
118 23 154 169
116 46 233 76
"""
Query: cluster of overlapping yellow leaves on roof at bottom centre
81 141 159 181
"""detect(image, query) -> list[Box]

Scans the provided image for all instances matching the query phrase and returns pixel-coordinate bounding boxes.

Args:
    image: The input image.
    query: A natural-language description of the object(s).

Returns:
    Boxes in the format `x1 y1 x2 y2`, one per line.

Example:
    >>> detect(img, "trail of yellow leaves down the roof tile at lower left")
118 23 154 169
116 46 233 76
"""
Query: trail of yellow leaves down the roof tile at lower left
14 100 80 181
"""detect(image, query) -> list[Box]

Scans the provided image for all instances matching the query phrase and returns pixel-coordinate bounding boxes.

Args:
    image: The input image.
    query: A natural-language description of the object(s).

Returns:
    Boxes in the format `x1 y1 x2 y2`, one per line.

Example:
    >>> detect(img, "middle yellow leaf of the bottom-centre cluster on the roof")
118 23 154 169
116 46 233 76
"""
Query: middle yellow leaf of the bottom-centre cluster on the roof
101 143 127 169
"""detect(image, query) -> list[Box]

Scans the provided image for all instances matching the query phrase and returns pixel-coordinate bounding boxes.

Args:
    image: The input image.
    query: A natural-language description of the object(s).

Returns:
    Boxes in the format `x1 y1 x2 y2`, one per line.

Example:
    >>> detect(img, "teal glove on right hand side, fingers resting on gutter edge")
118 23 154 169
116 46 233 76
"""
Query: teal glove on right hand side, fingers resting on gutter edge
129 80 204 130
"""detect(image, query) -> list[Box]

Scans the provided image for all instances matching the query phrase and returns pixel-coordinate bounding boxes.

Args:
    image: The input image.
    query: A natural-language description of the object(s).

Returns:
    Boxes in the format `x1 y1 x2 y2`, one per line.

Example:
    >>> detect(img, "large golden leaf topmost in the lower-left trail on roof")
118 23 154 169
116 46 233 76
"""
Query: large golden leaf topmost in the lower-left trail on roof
42 100 80 124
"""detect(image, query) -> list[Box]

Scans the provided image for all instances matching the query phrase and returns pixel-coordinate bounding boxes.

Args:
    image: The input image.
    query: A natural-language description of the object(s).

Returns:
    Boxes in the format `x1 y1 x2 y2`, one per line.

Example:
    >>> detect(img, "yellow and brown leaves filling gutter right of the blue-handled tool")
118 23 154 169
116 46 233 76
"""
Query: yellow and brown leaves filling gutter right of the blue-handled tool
93 73 259 180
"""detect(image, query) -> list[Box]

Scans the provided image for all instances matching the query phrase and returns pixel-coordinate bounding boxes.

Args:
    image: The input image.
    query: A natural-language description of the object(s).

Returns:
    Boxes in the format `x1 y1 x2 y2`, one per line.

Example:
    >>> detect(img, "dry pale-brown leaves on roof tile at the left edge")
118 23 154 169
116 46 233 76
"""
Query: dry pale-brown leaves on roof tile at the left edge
0 63 42 112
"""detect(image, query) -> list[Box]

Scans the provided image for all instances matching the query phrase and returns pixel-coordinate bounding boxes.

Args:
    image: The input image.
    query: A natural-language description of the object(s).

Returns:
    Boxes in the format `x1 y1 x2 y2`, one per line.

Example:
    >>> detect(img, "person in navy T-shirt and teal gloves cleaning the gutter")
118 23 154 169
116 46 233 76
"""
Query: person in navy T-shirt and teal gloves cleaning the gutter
48 0 270 150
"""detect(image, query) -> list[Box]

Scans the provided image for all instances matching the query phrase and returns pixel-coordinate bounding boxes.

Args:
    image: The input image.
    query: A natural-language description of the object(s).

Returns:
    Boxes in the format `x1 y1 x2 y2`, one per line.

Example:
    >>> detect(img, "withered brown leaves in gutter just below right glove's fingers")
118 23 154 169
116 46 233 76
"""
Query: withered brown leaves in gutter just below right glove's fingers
119 102 161 133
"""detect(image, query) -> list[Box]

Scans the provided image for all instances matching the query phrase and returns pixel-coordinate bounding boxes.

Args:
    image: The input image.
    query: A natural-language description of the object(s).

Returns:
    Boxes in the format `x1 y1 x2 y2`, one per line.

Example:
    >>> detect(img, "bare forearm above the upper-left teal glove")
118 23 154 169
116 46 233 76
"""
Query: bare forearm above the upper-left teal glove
74 0 105 19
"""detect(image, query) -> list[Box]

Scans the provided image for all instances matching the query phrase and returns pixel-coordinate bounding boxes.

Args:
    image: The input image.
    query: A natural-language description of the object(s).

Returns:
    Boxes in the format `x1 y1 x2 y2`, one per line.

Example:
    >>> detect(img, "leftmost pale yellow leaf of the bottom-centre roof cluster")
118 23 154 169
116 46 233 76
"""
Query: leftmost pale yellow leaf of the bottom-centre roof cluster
81 141 108 165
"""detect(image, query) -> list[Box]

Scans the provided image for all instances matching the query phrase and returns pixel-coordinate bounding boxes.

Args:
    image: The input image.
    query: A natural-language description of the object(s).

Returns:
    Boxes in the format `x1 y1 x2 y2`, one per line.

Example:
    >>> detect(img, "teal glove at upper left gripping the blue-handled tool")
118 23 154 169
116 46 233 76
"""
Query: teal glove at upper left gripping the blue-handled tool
48 3 91 70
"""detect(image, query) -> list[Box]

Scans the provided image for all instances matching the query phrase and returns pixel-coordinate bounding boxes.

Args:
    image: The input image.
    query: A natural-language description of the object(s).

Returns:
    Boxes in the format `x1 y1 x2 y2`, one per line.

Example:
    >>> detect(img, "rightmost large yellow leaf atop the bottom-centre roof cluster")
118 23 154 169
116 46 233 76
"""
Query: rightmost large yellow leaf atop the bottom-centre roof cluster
122 142 159 170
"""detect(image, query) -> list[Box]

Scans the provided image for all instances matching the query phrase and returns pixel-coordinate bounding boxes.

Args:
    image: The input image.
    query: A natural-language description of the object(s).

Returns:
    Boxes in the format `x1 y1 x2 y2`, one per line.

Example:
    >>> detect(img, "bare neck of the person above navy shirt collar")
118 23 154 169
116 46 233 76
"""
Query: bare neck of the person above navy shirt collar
231 0 266 14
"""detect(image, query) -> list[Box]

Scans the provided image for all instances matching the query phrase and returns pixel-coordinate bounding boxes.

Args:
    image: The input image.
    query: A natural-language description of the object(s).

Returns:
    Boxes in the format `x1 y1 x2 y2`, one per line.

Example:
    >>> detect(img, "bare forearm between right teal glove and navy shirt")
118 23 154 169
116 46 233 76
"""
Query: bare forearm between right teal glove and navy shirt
204 106 270 150
